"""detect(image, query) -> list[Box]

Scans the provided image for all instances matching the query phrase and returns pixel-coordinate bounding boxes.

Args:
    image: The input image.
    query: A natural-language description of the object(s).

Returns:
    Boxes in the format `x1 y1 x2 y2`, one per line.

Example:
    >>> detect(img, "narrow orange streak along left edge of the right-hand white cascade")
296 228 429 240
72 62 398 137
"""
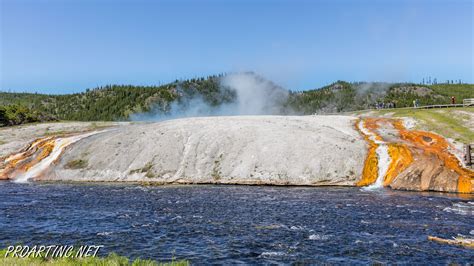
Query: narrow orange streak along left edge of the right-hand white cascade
355 120 378 187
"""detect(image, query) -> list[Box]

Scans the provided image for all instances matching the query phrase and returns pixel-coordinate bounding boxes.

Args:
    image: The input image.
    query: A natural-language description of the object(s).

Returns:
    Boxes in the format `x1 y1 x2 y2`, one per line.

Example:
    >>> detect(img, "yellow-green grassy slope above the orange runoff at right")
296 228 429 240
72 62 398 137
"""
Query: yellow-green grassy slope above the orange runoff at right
359 107 474 143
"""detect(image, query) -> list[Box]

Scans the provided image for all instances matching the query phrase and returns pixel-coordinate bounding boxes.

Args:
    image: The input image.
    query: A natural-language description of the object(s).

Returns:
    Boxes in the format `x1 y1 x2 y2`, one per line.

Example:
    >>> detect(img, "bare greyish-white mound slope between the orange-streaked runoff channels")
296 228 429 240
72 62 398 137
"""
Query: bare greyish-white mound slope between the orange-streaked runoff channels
44 116 367 185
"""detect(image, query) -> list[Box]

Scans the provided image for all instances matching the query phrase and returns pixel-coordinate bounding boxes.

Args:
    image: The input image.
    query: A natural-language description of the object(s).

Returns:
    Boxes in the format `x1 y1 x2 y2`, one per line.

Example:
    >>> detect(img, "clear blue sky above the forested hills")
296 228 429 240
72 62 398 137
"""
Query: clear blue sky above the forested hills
0 0 474 93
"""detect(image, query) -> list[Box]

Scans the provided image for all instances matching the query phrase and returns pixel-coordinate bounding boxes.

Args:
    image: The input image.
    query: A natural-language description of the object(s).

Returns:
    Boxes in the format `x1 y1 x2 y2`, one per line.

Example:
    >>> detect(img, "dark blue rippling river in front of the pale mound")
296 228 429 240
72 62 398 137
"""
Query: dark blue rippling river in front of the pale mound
0 182 474 264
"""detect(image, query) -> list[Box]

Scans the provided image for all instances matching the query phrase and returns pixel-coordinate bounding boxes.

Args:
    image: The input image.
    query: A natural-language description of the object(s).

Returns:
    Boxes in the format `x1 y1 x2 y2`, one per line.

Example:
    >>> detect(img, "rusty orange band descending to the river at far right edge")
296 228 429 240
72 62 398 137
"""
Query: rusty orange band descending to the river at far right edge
393 120 474 193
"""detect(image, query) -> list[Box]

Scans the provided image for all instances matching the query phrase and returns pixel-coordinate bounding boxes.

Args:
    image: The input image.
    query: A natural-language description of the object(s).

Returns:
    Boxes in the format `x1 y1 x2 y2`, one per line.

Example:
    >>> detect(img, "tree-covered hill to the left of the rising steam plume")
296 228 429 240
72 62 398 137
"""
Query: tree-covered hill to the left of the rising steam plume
0 75 235 125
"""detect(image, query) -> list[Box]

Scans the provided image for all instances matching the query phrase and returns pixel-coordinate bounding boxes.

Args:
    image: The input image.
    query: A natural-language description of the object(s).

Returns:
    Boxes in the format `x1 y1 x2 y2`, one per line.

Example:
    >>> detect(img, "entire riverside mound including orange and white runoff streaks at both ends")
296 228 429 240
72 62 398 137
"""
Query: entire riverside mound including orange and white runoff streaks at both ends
0 116 474 193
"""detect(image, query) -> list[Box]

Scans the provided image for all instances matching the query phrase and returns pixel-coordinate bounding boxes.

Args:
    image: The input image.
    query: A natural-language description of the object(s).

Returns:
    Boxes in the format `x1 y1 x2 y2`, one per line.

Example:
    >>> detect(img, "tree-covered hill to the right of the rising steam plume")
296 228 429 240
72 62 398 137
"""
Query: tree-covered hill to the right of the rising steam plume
288 81 474 114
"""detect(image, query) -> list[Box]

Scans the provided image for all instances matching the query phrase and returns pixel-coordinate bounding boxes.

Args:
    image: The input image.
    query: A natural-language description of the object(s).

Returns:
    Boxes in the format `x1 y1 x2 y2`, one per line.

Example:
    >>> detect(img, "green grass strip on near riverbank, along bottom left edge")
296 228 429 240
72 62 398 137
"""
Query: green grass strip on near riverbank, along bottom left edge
0 249 190 266
